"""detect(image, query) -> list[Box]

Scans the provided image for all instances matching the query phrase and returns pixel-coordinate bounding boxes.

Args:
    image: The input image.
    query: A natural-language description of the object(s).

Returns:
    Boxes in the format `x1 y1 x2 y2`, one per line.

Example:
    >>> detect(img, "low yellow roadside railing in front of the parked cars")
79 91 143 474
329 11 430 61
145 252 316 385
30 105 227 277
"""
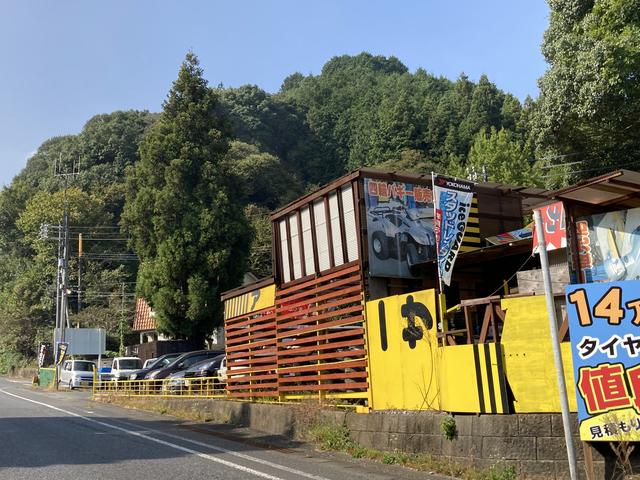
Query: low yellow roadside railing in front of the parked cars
93 377 227 398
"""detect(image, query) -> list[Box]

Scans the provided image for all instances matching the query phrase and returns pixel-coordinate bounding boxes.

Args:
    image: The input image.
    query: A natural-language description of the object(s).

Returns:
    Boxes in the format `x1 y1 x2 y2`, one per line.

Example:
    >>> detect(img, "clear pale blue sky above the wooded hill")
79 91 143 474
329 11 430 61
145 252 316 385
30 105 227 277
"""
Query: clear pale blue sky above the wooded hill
0 0 548 185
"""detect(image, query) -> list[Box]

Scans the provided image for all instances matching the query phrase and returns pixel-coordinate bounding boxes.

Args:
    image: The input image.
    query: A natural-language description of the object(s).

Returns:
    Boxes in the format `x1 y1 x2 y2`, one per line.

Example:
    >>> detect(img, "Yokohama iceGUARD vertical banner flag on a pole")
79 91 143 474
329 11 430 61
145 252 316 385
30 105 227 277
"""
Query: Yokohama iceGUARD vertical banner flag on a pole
433 174 475 285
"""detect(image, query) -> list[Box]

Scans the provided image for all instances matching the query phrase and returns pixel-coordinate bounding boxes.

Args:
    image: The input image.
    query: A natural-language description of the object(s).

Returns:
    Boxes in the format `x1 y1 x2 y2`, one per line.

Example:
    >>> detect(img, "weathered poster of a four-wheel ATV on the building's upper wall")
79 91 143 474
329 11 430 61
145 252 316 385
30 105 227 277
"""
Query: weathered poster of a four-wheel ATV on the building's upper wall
364 178 436 278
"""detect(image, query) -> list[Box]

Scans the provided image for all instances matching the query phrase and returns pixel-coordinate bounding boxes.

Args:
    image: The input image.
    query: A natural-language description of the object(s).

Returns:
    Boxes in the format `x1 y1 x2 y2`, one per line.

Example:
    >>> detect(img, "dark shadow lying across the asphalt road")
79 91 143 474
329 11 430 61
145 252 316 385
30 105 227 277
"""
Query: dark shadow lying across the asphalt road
0 416 296 469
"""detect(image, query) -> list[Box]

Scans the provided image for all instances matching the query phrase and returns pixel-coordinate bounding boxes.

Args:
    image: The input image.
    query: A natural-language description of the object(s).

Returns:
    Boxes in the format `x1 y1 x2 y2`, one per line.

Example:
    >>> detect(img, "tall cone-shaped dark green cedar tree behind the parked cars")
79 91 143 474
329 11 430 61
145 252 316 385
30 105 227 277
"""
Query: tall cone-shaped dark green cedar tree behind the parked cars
123 53 249 342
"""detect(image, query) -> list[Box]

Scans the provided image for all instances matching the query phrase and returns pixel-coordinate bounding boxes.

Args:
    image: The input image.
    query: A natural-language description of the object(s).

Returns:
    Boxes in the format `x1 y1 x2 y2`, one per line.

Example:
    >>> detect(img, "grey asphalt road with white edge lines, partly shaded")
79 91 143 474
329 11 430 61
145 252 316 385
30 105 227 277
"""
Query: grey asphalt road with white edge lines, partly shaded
0 378 442 480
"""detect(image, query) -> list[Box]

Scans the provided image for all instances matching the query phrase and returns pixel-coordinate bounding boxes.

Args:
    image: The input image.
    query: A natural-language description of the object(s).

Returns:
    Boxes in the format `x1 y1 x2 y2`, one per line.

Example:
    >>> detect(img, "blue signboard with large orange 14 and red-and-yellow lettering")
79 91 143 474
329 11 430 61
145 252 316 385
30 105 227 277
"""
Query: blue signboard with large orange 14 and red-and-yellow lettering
566 280 640 441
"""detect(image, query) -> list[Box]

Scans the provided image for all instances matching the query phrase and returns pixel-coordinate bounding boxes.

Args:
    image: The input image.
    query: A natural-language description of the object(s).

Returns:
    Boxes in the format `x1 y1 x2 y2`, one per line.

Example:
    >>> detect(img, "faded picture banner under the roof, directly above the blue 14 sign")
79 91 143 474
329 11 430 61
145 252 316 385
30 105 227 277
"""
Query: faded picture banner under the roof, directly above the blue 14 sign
576 208 640 283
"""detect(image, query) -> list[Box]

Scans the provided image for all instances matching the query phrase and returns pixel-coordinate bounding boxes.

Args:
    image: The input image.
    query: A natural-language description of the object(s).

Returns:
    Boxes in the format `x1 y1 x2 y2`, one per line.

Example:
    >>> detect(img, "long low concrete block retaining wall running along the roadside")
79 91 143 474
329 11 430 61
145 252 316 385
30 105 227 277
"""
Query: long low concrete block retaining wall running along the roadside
105 398 615 480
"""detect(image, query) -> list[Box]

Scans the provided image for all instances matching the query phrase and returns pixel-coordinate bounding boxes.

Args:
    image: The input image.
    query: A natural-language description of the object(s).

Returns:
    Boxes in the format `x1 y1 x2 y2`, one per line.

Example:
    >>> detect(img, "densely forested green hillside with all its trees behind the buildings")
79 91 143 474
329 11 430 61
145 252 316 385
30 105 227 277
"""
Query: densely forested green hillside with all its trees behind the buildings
0 1 640 369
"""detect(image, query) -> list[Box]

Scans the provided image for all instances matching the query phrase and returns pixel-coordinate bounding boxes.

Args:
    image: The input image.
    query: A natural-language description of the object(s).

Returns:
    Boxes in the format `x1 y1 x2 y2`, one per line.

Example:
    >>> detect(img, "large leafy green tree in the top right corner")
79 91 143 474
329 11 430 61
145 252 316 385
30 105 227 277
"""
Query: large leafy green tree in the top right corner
534 0 640 181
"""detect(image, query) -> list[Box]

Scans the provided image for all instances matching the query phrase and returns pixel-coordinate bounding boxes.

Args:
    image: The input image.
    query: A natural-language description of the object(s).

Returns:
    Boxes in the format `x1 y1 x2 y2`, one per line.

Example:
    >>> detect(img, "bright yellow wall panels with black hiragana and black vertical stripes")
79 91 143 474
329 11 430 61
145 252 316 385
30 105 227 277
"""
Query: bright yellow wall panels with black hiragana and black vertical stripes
366 290 509 413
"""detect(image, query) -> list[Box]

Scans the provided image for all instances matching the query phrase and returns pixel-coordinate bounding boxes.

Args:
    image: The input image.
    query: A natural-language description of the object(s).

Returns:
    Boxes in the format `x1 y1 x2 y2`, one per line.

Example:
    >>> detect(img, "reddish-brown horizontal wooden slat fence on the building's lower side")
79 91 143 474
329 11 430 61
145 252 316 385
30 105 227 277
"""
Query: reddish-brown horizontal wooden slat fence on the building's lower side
225 262 369 398
